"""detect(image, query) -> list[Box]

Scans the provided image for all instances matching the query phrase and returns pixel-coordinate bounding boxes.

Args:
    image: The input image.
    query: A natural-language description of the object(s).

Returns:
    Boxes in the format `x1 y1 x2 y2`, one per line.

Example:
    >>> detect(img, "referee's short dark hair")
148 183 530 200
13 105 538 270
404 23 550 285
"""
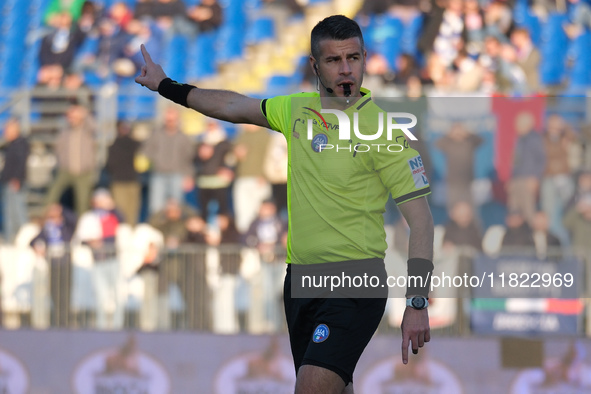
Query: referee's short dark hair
310 15 364 59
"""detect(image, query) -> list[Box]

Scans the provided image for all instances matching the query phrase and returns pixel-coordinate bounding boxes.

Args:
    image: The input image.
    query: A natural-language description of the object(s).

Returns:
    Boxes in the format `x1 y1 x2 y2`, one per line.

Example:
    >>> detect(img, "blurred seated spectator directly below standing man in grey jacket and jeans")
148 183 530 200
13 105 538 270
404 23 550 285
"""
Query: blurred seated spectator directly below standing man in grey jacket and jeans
148 198 196 249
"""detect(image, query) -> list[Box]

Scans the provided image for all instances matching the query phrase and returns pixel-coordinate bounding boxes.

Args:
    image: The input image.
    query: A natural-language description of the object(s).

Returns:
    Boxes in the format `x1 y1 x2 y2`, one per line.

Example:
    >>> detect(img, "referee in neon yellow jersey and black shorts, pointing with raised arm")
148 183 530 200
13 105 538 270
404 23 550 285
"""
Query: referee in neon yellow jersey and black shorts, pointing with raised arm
136 15 433 394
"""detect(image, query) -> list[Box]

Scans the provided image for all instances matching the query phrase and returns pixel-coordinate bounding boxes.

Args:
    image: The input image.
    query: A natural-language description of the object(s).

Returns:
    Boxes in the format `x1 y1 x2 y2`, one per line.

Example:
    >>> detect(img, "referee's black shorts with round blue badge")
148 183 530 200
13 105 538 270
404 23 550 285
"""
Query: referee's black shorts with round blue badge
283 264 387 385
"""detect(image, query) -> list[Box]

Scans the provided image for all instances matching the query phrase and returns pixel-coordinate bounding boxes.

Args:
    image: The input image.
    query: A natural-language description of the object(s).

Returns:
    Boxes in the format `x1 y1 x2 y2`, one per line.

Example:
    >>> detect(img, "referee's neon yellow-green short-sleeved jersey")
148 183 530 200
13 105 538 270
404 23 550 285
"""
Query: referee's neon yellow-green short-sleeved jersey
261 89 430 264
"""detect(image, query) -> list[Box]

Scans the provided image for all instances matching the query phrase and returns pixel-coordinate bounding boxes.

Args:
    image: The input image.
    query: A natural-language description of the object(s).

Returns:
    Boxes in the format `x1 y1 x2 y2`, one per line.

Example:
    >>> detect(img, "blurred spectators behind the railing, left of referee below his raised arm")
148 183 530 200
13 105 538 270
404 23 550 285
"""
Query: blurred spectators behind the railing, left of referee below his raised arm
0 104 288 331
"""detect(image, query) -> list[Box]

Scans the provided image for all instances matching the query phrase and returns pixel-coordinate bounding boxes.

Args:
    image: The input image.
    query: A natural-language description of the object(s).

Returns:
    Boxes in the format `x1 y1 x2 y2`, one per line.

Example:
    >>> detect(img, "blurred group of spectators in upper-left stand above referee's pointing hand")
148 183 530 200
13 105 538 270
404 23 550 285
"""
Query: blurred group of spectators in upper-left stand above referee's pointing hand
37 0 223 88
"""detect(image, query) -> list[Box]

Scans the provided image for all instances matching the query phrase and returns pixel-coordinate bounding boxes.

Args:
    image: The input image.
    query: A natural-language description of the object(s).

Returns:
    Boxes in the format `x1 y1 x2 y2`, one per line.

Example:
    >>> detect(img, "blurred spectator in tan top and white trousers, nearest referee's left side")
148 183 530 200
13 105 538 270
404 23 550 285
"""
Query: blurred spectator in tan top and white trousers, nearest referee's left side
233 125 271 233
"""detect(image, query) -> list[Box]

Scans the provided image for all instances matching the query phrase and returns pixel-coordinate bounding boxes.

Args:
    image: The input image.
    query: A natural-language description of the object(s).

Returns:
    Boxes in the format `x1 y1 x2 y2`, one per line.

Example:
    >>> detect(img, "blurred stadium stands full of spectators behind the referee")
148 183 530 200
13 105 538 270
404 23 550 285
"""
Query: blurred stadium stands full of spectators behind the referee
0 0 591 333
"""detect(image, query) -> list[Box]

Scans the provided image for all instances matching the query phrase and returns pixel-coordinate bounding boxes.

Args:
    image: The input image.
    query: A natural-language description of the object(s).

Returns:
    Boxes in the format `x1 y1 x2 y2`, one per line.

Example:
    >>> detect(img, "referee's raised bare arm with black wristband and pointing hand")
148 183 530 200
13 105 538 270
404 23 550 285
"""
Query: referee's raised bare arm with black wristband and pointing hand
135 44 270 128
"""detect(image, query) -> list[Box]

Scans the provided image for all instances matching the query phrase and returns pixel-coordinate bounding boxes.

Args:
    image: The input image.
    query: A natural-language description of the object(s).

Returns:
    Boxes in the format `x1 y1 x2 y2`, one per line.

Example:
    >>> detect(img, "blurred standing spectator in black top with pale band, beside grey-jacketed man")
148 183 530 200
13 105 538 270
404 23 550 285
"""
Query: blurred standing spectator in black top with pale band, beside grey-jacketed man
194 120 232 220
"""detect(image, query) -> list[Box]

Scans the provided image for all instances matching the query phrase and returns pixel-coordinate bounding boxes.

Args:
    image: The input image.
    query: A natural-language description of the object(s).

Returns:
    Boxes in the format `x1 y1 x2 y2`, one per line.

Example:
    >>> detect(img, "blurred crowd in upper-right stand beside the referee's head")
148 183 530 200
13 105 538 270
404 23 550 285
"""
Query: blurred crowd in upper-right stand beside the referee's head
358 0 591 95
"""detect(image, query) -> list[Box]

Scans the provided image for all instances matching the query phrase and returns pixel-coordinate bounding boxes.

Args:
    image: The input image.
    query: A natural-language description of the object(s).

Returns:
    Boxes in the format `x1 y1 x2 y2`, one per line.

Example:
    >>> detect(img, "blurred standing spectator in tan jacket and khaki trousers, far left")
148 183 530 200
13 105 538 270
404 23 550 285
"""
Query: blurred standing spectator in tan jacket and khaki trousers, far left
47 104 97 215
